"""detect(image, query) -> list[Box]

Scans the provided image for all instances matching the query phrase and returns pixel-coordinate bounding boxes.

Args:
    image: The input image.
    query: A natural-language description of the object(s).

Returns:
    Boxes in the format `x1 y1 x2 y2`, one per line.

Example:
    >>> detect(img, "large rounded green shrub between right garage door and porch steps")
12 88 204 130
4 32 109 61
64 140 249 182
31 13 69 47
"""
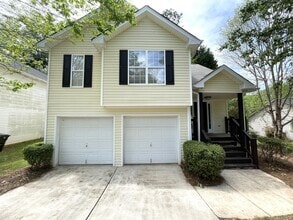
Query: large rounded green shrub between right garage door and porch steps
183 141 225 180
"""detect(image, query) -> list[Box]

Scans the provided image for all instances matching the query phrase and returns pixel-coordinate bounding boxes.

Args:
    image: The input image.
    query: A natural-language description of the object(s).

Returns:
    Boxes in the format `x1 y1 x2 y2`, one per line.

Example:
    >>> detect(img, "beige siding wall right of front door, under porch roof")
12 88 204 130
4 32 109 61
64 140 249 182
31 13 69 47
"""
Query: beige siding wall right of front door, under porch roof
211 99 227 133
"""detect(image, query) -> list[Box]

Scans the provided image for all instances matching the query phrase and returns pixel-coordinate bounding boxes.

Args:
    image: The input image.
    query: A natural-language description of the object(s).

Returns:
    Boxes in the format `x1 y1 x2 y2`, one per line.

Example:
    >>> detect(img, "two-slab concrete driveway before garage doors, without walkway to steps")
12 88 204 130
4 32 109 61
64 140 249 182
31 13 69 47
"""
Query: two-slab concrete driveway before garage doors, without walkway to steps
0 165 217 220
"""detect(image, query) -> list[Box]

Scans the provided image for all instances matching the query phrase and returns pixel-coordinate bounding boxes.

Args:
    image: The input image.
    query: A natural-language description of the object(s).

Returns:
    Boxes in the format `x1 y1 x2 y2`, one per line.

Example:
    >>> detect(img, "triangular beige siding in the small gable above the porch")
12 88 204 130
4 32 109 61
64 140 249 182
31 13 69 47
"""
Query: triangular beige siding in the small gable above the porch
200 71 242 93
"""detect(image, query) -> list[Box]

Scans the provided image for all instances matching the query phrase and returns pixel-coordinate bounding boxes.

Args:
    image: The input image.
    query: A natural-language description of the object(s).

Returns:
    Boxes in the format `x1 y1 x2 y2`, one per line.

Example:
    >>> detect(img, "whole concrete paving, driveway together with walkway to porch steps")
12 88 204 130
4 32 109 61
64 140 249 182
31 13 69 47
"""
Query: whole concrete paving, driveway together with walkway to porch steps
0 165 293 220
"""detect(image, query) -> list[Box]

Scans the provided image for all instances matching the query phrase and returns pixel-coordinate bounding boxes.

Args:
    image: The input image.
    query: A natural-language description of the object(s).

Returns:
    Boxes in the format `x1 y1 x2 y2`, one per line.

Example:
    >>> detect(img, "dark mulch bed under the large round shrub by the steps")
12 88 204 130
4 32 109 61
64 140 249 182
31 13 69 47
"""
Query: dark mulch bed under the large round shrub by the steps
181 164 224 187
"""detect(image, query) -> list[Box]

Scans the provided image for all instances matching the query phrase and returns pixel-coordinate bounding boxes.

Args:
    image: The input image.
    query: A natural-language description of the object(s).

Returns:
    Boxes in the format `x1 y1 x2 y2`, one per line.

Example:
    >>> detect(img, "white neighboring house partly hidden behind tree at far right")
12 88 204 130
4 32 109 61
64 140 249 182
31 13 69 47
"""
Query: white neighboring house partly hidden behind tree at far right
249 98 293 140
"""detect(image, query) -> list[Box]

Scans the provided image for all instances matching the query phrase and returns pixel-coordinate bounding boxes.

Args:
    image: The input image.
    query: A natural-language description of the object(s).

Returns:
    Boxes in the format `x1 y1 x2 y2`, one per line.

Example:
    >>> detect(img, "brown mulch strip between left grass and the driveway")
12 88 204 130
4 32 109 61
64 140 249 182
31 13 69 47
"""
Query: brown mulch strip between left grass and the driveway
0 168 51 195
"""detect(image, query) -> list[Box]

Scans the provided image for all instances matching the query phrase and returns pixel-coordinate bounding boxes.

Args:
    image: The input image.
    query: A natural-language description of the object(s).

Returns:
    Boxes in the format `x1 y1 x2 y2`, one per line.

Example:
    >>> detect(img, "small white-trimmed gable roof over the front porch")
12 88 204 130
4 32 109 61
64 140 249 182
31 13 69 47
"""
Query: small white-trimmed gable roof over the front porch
192 65 257 92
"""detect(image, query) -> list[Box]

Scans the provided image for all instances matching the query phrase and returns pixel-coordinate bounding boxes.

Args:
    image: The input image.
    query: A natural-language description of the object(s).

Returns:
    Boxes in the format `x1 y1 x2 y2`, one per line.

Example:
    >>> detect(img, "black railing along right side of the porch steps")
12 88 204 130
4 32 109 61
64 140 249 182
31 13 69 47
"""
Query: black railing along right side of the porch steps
228 118 258 168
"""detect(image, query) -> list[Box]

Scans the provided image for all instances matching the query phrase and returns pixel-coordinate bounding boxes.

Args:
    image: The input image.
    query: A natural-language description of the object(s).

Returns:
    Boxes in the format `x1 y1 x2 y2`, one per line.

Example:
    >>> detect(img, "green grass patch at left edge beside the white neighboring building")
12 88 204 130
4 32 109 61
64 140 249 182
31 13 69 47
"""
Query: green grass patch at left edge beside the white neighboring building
0 139 43 175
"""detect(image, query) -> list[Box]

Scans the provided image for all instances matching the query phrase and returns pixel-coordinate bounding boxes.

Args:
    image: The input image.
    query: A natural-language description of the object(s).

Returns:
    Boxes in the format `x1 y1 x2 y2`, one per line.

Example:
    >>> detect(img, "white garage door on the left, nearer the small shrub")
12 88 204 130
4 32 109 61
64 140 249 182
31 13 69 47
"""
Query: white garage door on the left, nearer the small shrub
59 118 113 164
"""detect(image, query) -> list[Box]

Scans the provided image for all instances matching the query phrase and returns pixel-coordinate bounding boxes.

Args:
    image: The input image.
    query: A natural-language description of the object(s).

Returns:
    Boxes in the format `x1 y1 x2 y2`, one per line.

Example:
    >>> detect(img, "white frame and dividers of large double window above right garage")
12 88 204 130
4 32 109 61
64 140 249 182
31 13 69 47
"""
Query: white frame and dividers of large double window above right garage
127 49 167 86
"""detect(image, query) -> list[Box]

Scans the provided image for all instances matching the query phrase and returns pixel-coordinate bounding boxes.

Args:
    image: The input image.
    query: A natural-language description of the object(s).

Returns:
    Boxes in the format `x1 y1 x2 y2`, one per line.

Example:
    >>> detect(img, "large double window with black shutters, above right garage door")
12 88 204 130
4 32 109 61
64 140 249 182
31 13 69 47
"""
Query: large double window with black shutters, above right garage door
128 51 166 85
